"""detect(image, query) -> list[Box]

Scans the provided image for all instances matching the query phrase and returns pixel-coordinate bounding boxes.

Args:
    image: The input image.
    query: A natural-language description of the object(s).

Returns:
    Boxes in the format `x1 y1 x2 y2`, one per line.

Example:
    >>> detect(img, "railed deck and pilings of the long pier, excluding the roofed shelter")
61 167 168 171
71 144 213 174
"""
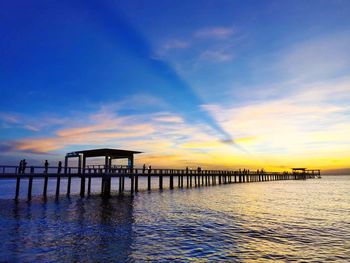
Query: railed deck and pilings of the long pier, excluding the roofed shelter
0 165 320 200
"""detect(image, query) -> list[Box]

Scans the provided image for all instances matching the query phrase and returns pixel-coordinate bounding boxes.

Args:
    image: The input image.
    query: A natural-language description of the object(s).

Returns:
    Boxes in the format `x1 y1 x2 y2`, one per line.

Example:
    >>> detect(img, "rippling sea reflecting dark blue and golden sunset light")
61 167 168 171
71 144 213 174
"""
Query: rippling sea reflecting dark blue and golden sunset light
0 176 350 262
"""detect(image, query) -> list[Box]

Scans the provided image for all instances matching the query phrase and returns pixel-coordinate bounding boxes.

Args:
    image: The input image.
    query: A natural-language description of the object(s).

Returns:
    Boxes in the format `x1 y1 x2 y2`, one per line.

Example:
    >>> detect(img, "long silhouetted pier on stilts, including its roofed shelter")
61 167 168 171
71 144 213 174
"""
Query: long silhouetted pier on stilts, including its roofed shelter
0 149 320 200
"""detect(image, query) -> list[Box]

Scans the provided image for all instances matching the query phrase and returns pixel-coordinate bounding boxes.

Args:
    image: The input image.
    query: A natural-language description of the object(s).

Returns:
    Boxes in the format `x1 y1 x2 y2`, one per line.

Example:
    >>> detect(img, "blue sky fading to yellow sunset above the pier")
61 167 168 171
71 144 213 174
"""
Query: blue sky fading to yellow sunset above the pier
0 0 350 171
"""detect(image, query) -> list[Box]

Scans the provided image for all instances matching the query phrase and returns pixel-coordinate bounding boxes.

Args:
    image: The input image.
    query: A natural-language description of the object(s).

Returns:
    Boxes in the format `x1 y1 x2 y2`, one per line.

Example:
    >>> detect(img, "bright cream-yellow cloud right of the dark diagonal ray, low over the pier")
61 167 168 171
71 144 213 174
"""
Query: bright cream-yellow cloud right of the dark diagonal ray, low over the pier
203 79 350 167
